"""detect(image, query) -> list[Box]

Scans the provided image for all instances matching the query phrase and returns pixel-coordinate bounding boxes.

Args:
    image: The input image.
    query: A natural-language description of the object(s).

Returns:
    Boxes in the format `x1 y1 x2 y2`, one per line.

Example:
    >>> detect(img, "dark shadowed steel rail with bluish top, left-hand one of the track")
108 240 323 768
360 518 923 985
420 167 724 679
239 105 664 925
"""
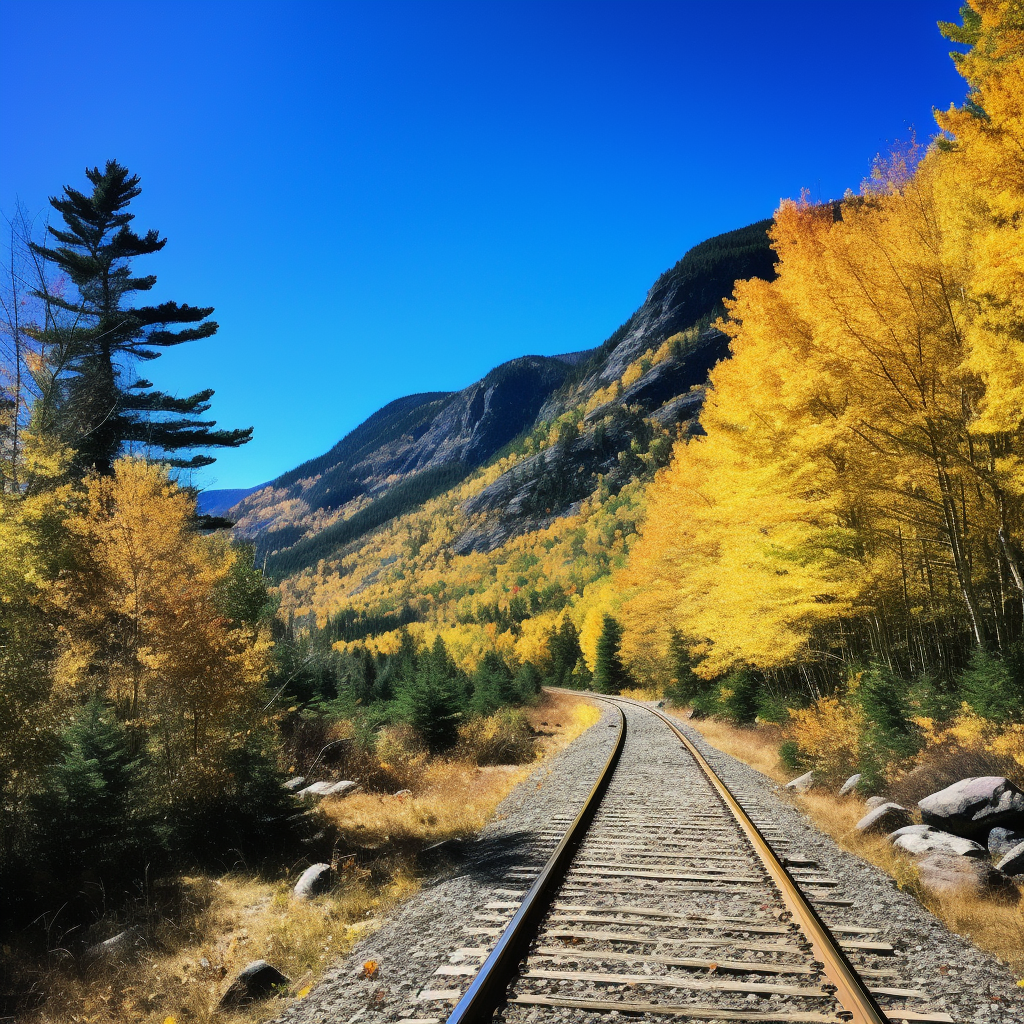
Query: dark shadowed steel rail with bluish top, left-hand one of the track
447 691 626 1024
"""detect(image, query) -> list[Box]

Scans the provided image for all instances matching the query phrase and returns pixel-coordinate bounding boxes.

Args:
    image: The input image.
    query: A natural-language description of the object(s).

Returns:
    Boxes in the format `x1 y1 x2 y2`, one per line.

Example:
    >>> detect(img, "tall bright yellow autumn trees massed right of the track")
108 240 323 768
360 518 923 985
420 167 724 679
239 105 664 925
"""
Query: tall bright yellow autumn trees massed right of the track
623 0 1024 782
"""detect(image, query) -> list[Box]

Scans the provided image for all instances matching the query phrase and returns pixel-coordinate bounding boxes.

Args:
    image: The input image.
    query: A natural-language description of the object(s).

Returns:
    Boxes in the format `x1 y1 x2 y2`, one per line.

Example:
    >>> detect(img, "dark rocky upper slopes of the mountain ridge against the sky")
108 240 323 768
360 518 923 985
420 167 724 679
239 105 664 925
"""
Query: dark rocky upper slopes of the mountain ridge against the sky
218 220 774 579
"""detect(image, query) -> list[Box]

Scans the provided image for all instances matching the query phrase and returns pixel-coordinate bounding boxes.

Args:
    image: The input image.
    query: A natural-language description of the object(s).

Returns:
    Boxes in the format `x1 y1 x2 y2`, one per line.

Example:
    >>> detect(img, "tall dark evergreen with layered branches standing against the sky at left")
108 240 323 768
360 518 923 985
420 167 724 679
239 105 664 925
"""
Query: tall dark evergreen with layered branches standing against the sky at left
33 160 252 474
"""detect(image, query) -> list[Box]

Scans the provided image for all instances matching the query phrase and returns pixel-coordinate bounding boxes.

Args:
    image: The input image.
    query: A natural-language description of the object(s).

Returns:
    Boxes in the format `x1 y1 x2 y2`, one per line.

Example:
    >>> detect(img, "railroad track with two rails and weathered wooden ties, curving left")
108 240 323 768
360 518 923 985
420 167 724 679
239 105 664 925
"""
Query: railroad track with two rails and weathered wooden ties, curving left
408 697 953 1024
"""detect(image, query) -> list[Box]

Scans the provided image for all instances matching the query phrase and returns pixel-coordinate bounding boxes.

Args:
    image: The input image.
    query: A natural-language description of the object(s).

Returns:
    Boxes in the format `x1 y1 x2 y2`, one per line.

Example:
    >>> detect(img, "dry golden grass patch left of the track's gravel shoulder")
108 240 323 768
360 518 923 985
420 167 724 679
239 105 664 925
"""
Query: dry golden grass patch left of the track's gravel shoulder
12 693 601 1024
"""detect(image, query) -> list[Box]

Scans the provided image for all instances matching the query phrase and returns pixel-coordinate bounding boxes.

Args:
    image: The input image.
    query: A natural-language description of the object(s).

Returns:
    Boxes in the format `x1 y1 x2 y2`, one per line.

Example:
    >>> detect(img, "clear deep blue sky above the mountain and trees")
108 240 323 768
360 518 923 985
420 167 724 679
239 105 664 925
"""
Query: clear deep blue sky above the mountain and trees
0 0 964 486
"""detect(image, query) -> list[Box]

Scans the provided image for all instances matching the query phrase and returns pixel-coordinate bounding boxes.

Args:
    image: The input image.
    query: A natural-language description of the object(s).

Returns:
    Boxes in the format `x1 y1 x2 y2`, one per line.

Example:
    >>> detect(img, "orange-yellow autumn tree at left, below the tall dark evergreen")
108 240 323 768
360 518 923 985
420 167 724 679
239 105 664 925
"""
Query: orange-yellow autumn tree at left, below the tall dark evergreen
52 458 271 799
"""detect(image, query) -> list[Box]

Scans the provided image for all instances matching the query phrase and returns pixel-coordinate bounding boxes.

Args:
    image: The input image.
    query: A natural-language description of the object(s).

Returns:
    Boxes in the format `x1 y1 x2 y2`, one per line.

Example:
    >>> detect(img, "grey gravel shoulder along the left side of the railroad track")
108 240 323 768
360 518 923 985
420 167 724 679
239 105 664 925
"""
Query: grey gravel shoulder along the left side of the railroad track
268 710 617 1024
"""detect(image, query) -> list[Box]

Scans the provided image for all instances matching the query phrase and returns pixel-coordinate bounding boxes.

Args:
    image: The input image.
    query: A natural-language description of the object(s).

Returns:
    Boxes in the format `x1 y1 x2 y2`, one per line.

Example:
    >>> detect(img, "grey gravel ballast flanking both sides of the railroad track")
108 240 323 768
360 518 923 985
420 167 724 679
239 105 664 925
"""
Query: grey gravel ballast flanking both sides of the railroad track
270 709 1024 1024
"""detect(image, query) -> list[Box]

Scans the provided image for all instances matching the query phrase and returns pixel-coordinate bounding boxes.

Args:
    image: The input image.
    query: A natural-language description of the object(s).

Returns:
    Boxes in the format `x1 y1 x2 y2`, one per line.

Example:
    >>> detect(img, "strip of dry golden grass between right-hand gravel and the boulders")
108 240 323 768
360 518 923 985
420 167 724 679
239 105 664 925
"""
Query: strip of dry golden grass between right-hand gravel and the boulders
670 712 1024 975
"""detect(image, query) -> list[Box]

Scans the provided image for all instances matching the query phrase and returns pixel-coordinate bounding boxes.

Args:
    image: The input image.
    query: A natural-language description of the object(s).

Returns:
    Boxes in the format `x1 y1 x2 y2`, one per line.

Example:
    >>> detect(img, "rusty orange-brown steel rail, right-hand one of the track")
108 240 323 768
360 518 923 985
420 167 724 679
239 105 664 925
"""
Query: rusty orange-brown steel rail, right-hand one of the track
614 697 898 1024
